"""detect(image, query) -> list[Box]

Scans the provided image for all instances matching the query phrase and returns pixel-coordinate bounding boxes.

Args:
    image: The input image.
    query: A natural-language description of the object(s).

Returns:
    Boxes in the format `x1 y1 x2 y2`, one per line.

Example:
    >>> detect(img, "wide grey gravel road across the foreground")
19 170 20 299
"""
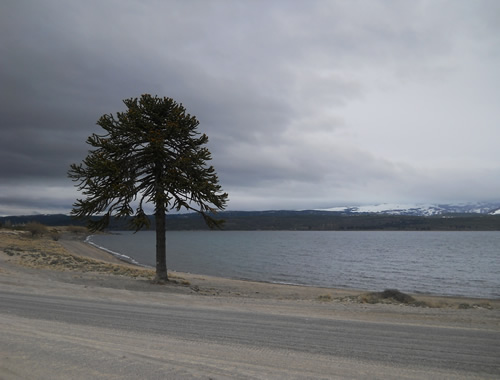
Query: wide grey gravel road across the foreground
0 292 500 379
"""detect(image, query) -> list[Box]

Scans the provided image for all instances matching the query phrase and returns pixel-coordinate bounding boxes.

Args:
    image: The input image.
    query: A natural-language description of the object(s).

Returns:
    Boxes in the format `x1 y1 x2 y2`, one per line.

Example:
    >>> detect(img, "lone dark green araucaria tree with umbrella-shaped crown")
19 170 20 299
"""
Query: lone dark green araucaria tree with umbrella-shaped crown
68 94 228 281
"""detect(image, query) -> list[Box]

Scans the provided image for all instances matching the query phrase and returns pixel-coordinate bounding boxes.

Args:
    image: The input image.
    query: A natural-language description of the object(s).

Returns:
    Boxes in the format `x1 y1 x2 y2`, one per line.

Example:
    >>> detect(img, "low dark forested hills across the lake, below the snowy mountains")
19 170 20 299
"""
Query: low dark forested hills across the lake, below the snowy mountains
0 211 500 231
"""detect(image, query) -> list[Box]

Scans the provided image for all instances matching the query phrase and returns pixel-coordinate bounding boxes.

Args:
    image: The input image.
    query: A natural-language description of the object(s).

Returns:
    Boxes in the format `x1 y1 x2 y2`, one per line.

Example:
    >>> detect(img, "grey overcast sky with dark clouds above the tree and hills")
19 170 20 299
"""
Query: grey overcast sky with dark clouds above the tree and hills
0 0 500 215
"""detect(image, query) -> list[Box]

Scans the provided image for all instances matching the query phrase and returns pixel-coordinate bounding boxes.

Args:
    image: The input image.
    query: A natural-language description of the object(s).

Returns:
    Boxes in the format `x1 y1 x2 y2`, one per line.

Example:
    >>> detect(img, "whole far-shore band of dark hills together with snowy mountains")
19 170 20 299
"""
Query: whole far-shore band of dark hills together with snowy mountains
0 202 500 231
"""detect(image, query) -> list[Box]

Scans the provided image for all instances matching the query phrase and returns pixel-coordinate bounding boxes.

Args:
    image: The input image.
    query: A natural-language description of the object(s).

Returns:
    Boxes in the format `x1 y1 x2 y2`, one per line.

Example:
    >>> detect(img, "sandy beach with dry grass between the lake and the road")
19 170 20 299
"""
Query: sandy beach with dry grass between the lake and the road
0 230 500 379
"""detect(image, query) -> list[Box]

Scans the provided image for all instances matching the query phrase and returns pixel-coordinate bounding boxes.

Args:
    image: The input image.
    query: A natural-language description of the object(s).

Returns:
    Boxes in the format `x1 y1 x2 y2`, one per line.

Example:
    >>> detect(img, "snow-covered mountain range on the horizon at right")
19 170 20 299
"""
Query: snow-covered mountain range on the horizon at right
318 202 500 216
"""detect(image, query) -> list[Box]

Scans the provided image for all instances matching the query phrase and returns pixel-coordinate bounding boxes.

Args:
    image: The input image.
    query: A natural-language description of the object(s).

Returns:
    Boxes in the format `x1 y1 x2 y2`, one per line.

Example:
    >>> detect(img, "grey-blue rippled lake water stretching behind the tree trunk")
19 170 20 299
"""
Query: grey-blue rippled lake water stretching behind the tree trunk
89 231 500 298
